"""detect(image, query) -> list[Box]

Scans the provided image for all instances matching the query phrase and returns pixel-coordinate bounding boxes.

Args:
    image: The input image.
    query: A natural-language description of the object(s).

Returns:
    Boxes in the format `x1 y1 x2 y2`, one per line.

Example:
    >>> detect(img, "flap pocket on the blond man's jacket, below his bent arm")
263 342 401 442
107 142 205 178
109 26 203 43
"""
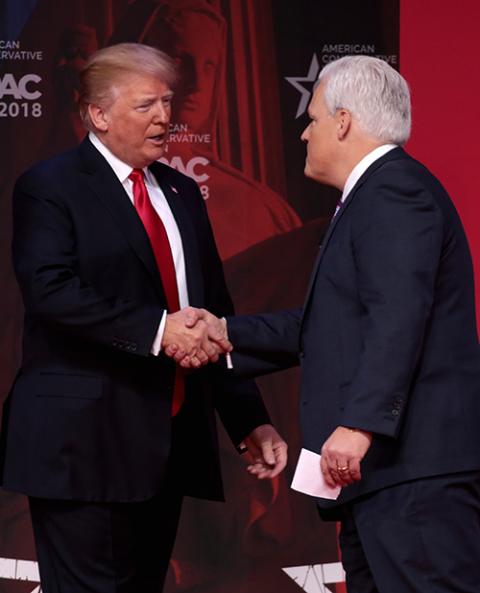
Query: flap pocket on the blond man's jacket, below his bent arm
35 372 103 399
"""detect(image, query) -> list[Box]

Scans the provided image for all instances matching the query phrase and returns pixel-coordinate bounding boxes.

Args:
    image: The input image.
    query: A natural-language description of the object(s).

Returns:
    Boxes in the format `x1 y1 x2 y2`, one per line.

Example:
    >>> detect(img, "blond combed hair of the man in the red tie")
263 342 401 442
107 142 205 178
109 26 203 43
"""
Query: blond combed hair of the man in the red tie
78 43 177 130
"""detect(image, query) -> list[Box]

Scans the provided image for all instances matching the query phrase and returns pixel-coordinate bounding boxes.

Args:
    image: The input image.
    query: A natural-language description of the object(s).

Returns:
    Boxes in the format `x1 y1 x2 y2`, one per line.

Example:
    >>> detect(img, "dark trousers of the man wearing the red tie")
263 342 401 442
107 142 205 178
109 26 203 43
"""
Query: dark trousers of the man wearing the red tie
29 411 189 593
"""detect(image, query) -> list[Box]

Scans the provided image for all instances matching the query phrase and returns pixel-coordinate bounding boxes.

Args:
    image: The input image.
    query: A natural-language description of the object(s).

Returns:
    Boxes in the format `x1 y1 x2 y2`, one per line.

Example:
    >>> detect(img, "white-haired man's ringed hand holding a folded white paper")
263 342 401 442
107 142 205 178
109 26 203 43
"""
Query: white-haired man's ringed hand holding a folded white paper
320 426 372 487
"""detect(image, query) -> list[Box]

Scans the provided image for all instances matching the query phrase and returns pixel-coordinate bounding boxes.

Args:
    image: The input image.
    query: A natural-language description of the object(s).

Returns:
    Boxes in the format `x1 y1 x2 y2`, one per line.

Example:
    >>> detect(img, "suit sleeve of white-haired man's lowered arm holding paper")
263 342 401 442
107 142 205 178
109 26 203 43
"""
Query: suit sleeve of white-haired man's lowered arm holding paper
341 172 444 437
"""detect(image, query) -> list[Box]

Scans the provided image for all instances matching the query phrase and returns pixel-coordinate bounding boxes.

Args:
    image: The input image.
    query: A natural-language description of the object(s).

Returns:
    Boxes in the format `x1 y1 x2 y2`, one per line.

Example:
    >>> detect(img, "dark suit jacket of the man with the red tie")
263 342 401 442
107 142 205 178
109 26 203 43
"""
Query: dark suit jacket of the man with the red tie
2 139 268 501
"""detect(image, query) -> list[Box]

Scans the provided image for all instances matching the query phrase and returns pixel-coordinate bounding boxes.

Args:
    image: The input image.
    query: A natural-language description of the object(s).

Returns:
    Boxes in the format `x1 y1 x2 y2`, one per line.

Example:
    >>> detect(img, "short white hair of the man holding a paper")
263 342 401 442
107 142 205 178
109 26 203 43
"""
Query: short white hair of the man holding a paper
318 56 412 146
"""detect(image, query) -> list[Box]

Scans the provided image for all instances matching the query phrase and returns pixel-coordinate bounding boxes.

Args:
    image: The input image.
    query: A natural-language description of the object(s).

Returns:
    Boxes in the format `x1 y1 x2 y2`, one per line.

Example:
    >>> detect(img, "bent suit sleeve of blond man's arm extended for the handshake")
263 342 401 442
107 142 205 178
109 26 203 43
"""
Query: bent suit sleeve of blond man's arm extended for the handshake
13 172 163 356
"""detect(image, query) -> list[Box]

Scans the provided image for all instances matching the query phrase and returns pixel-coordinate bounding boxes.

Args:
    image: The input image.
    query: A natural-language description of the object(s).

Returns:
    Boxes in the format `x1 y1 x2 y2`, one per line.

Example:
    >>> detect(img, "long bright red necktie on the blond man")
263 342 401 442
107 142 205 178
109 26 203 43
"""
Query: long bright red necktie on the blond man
128 169 185 416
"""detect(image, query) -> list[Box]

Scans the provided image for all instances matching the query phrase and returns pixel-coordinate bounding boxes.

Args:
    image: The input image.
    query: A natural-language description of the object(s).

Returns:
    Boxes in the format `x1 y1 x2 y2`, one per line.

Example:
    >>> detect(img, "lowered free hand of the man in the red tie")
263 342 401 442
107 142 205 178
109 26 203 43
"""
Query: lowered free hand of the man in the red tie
243 424 288 480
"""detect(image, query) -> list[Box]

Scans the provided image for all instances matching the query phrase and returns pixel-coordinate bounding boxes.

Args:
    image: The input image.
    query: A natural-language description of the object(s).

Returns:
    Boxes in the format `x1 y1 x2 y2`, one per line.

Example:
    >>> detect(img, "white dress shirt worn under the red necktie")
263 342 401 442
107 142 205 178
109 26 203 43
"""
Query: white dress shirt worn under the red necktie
88 132 188 355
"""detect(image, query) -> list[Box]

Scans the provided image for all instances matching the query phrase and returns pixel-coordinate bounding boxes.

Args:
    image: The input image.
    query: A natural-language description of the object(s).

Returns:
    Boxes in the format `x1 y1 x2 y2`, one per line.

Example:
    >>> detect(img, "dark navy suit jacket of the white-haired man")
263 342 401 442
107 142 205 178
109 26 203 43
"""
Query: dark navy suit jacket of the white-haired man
228 148 480 504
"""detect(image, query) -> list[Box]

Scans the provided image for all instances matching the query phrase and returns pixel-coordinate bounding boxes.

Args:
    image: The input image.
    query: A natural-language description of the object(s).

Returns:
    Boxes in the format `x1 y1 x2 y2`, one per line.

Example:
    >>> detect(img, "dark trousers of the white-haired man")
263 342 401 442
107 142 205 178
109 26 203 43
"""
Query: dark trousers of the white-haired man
340 472 480 593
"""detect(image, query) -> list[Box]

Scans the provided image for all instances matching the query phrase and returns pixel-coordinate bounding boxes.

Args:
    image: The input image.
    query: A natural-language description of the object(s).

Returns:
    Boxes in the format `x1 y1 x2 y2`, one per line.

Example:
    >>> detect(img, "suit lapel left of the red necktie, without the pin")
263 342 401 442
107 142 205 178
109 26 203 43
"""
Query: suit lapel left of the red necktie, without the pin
79 139 166 302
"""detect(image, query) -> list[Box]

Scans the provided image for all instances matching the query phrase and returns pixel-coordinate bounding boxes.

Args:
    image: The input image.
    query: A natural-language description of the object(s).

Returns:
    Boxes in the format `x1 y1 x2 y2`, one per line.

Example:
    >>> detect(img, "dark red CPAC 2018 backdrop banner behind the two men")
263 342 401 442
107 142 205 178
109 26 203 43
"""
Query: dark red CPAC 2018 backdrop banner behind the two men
0 0 399 593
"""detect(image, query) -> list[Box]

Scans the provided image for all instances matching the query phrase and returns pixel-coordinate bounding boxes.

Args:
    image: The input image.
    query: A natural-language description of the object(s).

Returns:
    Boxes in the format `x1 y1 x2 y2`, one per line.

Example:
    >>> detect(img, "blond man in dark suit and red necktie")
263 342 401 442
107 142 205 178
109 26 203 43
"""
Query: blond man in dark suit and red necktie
2 44 286 593
